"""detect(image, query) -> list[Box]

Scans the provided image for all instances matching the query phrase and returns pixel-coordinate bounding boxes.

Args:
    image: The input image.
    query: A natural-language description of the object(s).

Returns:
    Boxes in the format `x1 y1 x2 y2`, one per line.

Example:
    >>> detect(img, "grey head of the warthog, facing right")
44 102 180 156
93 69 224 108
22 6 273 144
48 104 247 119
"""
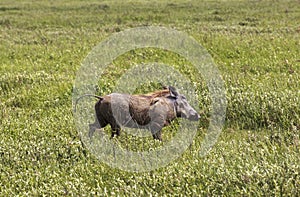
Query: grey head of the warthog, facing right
169 86 200 121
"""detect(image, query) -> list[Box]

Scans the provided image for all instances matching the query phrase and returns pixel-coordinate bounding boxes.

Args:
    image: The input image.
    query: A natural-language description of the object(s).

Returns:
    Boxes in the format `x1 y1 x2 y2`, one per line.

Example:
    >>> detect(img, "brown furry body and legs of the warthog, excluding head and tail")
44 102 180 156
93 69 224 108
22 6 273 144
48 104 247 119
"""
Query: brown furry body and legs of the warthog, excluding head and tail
89 89 176 140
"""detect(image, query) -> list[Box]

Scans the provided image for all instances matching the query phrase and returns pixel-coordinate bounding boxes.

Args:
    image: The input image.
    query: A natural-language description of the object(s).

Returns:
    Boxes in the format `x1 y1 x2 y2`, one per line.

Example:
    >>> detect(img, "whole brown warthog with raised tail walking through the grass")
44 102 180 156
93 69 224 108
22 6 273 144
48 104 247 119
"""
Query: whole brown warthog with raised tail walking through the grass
76 86 200 141
